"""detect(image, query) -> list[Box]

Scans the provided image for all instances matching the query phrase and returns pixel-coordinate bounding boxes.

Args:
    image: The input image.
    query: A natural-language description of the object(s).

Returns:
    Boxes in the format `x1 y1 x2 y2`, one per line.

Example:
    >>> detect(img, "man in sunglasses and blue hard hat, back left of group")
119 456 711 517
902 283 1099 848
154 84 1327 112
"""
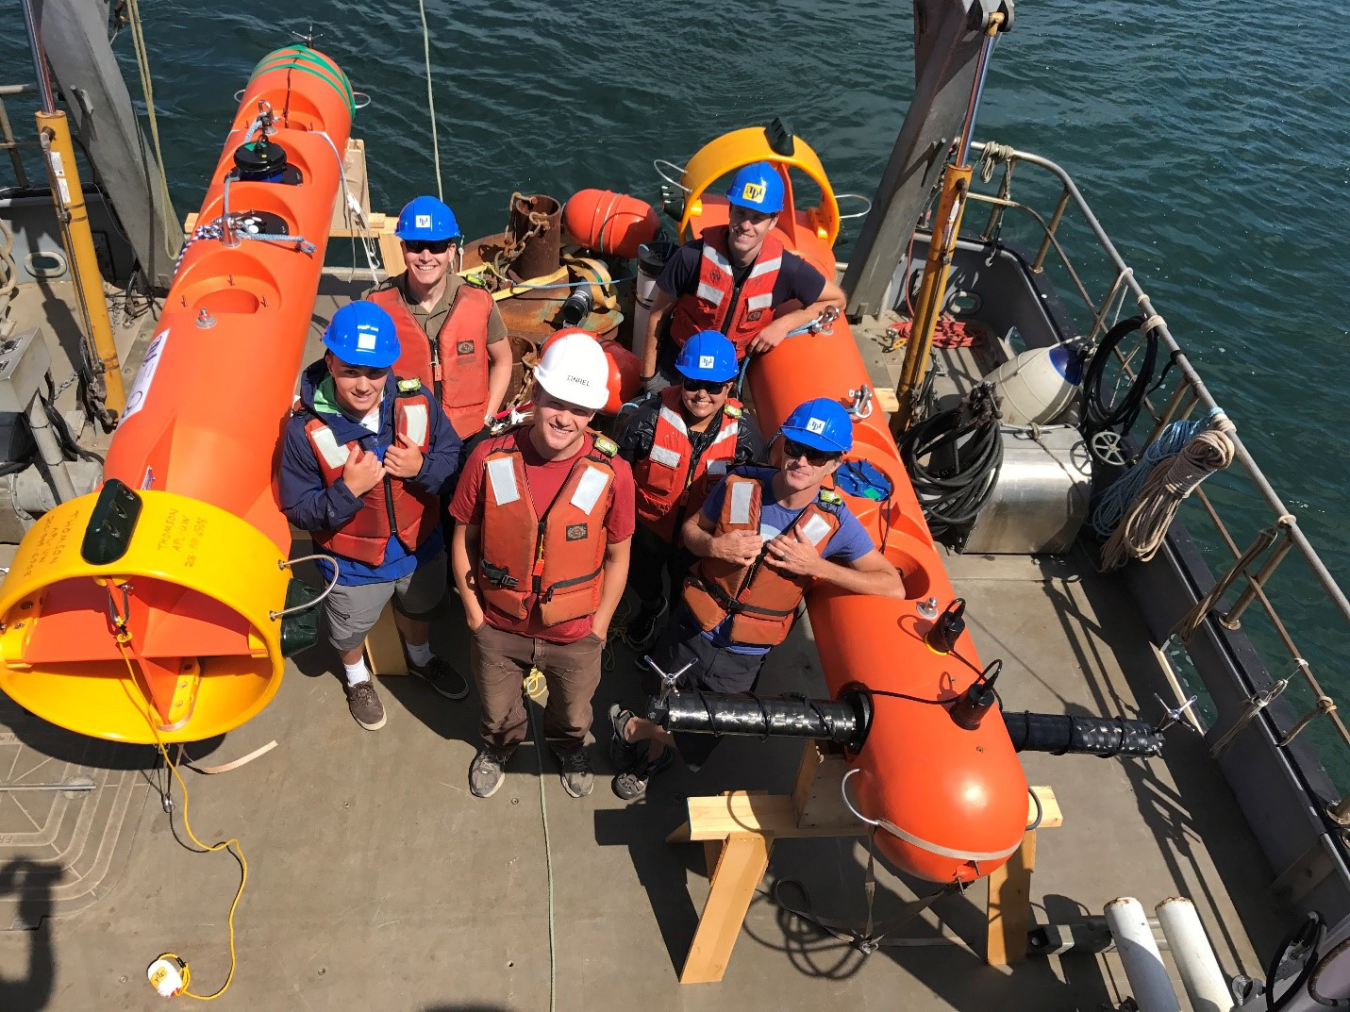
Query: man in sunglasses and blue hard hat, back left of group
362 197 512 440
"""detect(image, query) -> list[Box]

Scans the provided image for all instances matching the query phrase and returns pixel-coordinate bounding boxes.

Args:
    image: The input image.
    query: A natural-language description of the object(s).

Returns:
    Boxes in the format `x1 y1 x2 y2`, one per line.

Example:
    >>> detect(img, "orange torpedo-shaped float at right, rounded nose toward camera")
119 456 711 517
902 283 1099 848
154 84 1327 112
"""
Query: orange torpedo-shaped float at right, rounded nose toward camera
669 130 1027 882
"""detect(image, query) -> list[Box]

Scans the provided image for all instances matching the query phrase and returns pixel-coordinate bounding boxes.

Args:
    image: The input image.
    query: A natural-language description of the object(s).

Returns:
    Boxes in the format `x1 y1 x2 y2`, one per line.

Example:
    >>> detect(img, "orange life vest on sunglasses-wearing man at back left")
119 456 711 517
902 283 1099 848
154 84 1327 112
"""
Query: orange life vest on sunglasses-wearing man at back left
367 281 493 439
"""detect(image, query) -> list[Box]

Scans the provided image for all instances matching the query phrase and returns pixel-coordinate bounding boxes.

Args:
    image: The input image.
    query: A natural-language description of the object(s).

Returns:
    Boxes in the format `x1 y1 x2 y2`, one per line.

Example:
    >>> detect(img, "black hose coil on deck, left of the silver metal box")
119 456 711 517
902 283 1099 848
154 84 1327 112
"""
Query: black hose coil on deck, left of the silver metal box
900 383 1003 541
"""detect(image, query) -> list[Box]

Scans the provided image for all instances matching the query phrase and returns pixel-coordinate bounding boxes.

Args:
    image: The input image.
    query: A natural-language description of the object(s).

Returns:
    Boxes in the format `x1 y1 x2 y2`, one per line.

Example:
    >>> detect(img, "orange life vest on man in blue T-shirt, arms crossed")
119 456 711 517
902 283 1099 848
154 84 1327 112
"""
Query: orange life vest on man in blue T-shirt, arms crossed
684 472 842 646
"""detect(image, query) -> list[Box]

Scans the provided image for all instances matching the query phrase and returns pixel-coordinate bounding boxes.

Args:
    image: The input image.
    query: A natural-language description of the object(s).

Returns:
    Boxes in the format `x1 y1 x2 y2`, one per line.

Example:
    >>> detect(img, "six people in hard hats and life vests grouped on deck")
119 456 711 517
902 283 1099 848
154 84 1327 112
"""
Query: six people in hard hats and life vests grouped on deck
279 162 903 800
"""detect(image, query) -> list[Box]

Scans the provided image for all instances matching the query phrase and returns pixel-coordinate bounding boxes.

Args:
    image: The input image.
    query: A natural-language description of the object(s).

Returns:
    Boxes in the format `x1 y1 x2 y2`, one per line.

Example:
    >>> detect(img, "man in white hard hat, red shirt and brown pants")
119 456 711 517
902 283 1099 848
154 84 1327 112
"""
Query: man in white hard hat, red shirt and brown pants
450 333 635 797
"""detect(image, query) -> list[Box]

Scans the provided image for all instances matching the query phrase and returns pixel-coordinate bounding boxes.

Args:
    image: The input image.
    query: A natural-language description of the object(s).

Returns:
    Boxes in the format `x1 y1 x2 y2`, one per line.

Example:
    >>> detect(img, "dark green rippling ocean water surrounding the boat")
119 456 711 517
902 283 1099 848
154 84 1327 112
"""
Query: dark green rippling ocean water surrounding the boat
0 0 1350 734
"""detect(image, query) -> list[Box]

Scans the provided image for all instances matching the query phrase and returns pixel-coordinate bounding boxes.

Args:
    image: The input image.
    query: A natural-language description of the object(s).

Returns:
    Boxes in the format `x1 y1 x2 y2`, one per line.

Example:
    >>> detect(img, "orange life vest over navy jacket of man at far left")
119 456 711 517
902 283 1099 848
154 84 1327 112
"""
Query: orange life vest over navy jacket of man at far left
296 376 440 565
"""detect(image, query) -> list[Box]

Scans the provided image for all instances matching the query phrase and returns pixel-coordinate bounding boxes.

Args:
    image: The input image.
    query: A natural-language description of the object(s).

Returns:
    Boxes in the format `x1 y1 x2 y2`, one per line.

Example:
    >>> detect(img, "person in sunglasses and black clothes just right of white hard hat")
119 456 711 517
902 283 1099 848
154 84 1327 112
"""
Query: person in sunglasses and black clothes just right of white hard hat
618 331 764 650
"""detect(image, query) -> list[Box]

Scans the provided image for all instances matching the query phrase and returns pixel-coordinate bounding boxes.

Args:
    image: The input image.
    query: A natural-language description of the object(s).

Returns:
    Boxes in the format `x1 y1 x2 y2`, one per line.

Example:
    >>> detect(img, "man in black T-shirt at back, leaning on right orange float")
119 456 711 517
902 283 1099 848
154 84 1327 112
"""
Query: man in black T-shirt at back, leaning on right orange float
643 162 845 389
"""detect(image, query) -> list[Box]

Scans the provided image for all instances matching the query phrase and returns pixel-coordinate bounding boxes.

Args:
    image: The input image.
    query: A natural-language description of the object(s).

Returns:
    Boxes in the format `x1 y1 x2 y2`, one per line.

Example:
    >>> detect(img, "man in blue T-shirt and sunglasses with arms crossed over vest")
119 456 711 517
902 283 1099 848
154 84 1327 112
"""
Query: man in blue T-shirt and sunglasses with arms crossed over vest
610 398 905 800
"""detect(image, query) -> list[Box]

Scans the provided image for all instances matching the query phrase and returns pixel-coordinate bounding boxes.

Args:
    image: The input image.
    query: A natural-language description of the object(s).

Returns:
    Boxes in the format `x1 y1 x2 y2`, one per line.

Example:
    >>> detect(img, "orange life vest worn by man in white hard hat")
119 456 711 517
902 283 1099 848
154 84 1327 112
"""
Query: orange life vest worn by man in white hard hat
478 432 617 626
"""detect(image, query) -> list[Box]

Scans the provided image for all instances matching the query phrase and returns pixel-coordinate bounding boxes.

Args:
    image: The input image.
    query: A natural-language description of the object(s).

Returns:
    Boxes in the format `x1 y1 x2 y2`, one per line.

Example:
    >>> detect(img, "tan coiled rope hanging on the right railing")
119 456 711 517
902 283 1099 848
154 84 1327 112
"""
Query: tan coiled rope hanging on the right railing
1102 416 1234 569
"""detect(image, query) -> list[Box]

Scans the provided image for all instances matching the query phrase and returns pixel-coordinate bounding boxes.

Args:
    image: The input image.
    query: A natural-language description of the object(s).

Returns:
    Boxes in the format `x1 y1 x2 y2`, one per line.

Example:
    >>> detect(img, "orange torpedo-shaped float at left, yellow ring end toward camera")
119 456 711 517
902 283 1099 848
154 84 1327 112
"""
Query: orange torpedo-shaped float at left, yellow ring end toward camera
0 46 354 743
